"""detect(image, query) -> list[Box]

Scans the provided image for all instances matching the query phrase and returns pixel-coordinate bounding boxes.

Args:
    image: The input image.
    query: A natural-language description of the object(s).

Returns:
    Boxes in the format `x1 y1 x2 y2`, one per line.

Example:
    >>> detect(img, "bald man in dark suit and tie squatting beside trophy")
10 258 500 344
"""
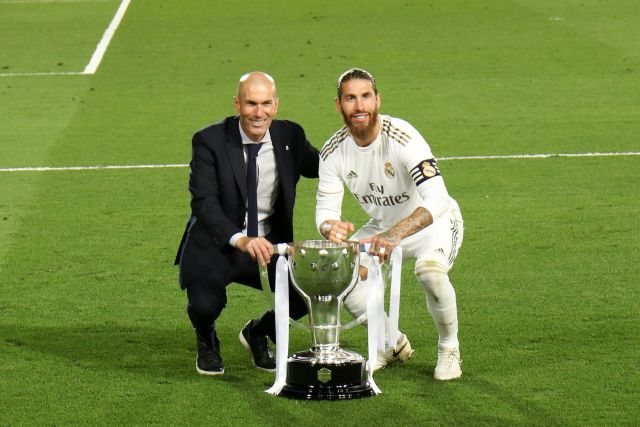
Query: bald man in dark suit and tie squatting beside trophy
176 72 318 375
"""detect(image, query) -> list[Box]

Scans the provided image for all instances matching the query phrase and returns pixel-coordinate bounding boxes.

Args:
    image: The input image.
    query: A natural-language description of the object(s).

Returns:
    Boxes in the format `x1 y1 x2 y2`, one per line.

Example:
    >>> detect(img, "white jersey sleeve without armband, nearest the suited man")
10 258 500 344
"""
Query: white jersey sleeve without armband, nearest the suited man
316 151 344 231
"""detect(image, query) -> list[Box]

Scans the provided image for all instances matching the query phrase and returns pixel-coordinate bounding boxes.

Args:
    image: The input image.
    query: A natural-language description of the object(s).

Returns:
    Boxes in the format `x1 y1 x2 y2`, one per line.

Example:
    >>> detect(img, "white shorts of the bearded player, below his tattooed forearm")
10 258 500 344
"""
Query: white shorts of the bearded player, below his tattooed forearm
350 206 464 271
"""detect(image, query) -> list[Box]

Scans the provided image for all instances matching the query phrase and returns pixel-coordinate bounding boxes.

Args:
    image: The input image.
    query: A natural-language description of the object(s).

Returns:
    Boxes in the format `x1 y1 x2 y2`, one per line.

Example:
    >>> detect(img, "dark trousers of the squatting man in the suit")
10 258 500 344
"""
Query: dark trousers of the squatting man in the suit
180 249 307 342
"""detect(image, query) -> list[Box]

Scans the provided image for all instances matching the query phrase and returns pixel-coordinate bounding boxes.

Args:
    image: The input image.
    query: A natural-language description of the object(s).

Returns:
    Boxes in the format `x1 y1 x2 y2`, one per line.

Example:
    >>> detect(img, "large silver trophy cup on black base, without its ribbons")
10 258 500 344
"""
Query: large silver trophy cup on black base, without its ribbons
280 240 375 400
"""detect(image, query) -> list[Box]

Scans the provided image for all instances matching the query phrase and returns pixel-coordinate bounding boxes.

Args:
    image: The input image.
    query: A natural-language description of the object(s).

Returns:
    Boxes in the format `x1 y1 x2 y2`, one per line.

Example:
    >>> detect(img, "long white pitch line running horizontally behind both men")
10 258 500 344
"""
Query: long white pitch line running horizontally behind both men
0 151 640 172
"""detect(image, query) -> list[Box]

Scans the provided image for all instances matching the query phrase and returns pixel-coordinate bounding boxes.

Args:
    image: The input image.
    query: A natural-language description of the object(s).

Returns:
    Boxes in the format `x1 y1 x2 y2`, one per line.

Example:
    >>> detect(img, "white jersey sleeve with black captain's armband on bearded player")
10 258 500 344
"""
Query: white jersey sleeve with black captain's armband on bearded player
403 125 451 221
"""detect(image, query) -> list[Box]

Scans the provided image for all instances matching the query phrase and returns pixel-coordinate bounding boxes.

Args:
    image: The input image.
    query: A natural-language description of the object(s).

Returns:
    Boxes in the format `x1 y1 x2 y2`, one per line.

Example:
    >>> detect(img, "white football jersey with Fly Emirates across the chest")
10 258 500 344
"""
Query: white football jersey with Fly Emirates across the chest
316 115 457 228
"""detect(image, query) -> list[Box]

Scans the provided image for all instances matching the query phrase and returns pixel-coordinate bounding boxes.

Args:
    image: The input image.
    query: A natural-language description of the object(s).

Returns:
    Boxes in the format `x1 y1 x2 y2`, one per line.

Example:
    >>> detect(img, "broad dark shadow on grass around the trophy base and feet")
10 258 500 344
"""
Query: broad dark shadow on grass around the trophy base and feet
0 324 562 425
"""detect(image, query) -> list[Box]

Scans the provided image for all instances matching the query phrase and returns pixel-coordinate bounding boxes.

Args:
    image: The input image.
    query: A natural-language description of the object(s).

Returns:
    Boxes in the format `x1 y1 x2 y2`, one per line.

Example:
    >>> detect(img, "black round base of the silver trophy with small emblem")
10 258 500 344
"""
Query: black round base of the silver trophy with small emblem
279 358 375 400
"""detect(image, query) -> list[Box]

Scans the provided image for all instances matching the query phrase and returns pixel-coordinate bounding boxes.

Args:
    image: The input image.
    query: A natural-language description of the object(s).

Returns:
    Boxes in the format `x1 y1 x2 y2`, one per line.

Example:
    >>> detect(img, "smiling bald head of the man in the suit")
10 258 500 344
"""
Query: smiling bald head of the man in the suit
233 71 278 142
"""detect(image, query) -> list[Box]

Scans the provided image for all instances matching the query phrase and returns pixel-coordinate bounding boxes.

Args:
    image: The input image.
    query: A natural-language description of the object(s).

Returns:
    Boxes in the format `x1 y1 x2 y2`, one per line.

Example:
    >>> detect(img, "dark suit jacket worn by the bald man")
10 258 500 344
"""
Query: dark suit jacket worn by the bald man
175 117 319 288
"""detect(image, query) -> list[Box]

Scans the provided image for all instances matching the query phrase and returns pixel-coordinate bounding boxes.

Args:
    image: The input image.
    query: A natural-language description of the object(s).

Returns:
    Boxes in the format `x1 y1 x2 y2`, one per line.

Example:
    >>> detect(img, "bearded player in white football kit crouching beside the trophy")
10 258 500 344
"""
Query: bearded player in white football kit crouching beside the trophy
316 68 463 380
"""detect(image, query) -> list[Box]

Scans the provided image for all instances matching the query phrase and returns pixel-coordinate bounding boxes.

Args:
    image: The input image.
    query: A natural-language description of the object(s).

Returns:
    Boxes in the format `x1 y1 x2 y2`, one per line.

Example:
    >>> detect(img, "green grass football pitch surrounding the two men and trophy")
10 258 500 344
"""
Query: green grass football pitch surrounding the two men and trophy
0 0 640 426
